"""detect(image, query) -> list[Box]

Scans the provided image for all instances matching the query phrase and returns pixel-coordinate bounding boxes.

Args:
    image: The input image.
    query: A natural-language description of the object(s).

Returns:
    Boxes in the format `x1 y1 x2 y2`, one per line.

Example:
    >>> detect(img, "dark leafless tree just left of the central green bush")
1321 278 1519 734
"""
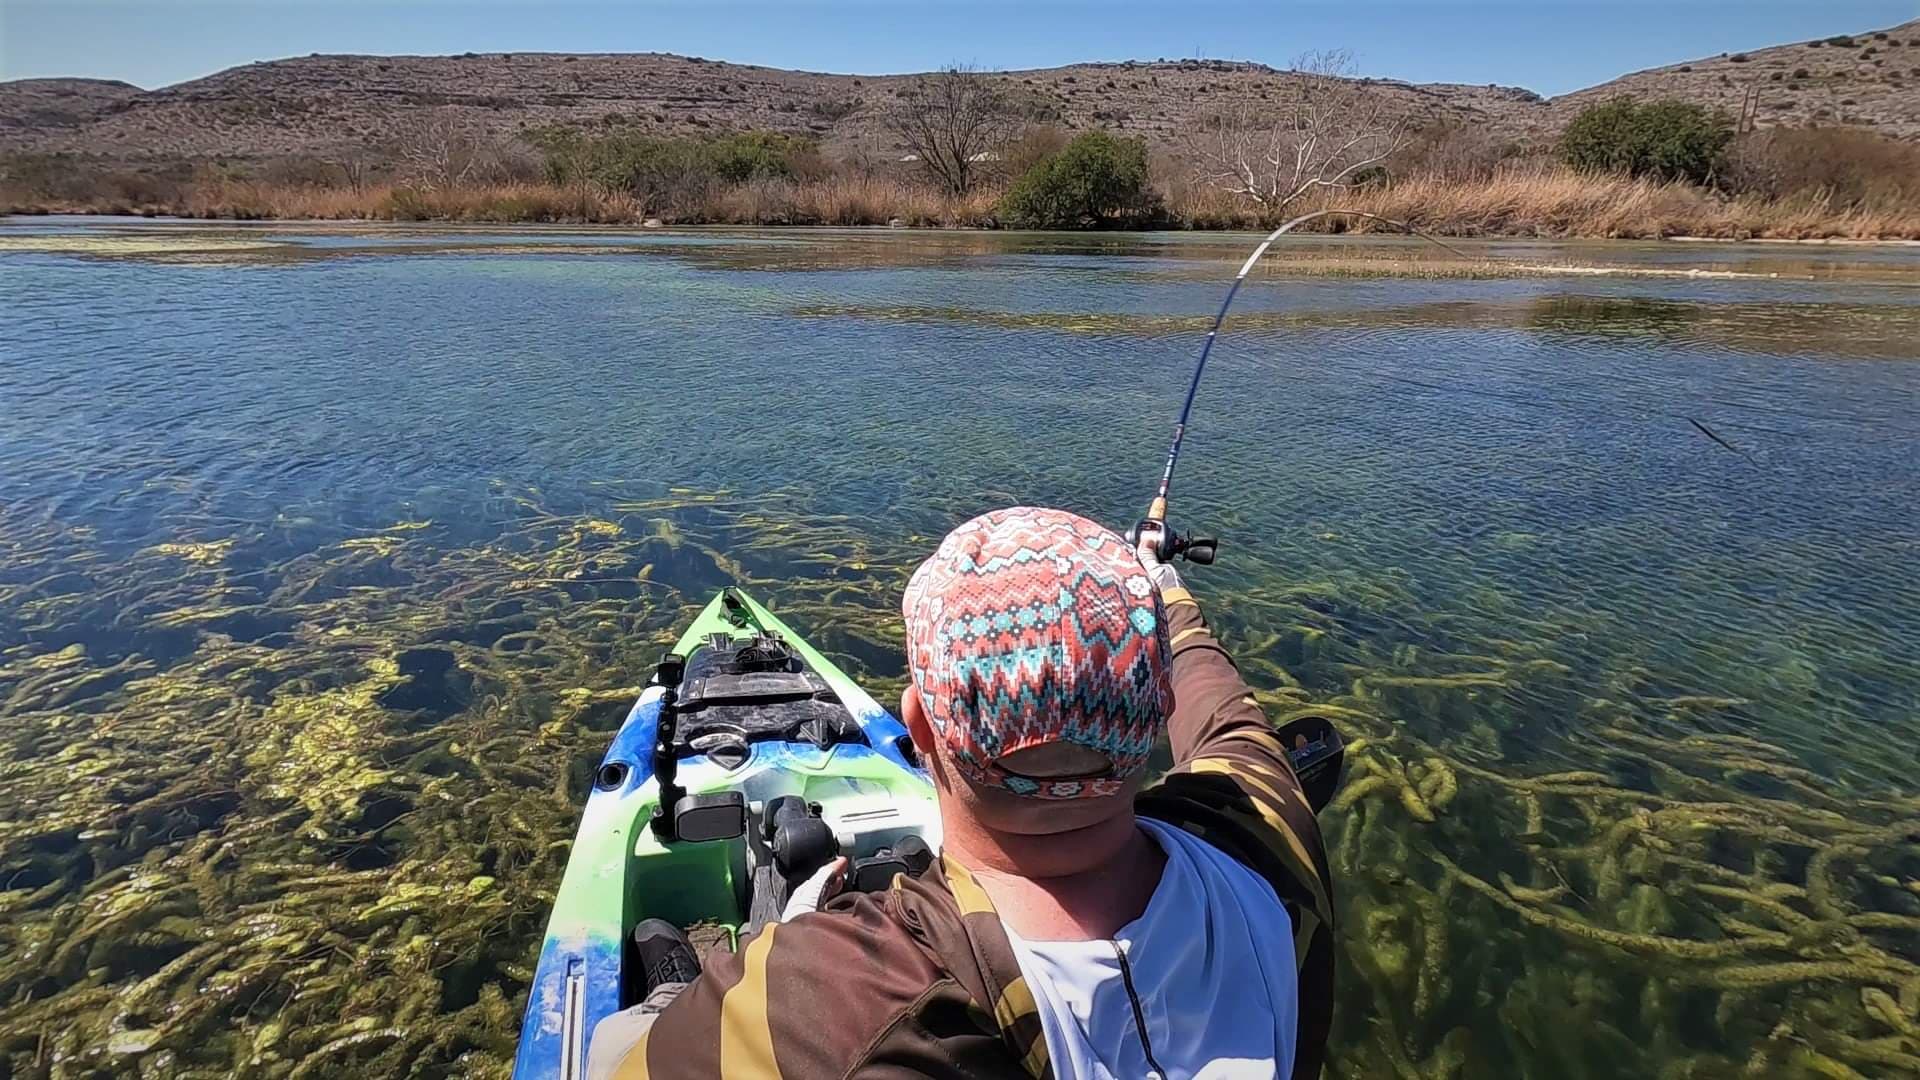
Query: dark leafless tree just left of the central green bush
887 65 1020 196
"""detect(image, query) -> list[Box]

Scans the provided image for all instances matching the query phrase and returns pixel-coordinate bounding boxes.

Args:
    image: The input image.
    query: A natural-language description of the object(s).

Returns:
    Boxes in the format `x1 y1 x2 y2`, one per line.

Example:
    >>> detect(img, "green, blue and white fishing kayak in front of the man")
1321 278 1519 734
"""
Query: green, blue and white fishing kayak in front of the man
513 588 939 1080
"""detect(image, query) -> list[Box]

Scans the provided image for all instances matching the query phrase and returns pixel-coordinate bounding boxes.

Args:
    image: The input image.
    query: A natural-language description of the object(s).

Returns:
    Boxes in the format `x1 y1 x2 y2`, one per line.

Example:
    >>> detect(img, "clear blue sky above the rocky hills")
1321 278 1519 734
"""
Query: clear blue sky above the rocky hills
0 0 1920 94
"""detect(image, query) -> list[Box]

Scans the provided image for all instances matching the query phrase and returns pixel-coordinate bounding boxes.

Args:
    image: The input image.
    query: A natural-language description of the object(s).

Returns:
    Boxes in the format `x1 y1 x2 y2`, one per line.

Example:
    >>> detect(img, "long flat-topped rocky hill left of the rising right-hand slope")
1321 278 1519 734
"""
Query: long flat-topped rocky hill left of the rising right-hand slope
0 54 1540 160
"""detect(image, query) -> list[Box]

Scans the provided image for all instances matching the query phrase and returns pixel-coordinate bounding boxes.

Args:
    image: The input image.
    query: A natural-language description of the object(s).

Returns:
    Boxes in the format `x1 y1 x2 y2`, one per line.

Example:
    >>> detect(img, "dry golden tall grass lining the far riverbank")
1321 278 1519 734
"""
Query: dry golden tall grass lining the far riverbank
0 163 1920 240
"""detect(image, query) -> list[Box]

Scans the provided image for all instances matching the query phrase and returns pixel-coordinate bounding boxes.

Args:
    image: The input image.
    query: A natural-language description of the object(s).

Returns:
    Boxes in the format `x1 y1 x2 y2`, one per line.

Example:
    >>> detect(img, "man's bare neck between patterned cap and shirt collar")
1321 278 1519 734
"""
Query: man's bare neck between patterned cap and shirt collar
941 809 1167 942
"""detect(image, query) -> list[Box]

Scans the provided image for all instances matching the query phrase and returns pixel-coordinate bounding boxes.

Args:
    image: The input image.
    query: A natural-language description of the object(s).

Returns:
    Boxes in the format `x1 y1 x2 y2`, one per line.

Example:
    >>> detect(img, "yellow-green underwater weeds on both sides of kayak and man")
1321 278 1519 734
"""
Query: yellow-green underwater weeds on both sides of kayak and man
0 490 1920 1080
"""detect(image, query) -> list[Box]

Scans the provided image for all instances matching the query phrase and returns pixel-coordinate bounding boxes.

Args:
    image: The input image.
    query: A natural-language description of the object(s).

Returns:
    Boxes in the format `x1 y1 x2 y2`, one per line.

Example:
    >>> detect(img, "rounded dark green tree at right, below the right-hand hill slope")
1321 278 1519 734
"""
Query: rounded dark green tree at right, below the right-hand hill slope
1559 98 1734 184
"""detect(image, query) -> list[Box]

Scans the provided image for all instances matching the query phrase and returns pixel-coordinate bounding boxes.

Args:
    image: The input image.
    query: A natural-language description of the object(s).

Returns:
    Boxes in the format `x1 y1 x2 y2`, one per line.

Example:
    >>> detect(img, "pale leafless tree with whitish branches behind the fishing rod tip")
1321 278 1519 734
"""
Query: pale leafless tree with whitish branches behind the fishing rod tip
1188 50 1409 211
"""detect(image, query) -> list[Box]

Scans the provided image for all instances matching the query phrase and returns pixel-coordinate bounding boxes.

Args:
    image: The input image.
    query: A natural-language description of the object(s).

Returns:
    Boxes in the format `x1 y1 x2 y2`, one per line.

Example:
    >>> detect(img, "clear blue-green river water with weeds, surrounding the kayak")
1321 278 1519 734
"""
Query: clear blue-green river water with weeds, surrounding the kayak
0 214 1920 1076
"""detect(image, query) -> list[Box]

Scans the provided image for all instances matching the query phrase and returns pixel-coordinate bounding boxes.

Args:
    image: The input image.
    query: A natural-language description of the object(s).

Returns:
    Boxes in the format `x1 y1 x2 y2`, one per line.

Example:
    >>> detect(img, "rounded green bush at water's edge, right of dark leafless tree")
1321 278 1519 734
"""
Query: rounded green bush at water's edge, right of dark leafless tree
1000 131 1158 229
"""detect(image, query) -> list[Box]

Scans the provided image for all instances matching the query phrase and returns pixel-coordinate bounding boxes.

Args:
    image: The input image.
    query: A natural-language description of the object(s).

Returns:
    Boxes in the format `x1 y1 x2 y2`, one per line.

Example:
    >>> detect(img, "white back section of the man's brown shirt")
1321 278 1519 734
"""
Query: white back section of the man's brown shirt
1006 819 1300 1080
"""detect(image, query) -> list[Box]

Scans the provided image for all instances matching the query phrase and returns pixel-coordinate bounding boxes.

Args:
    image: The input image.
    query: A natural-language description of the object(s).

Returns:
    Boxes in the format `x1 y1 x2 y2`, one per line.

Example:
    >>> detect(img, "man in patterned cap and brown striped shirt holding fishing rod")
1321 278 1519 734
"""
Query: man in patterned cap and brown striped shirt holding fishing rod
589 507 1332 1080
